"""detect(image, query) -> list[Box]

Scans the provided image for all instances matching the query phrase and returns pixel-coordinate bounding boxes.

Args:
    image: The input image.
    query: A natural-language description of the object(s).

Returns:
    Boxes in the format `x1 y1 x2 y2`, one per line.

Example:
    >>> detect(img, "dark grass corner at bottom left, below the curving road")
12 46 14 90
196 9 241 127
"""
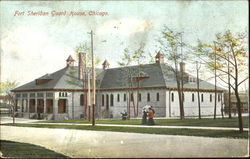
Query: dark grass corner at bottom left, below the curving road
0 140 69 158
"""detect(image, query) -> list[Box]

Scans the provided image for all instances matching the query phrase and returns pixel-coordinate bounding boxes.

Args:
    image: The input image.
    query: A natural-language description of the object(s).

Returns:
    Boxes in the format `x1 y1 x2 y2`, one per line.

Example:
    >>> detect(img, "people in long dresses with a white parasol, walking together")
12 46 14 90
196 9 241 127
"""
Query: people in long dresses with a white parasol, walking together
141 106 155 125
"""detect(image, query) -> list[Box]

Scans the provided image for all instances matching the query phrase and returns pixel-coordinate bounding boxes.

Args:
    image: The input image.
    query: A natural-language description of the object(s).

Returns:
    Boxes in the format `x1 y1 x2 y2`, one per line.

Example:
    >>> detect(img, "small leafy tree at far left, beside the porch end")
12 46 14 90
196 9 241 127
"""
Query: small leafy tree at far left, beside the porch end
0 81 18 124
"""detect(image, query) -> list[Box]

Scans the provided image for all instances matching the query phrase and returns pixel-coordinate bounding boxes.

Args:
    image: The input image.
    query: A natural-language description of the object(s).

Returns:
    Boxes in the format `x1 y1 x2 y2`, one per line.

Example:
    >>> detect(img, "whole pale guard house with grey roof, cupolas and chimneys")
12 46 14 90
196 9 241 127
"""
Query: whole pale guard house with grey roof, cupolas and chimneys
12 53 224 120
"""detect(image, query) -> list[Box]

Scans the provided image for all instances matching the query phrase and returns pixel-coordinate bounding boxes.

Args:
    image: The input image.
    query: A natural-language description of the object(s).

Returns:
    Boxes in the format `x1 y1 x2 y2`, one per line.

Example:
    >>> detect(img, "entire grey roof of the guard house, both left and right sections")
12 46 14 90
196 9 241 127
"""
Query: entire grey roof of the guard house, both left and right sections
12 63 224 91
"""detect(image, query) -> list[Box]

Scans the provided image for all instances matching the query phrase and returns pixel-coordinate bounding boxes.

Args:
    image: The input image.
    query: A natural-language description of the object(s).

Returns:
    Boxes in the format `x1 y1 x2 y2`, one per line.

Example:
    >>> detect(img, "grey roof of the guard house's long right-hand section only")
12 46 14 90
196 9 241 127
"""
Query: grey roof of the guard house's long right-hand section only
100 63 224 90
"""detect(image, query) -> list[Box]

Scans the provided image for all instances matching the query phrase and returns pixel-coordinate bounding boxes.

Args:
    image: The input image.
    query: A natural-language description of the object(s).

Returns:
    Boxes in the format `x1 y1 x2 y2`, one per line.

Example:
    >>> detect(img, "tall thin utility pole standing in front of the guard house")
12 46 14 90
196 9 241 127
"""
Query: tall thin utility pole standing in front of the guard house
90 30 96 126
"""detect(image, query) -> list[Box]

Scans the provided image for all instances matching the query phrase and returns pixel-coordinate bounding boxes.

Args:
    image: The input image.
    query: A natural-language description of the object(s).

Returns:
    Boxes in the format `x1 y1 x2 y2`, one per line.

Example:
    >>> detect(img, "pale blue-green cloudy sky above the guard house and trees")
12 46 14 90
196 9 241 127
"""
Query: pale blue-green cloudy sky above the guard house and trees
0 1 249 90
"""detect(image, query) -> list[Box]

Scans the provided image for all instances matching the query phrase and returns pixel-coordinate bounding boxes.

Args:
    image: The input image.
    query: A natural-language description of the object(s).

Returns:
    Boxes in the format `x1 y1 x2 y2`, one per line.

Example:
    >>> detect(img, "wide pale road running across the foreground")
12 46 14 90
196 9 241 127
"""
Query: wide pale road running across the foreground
1 126 249 158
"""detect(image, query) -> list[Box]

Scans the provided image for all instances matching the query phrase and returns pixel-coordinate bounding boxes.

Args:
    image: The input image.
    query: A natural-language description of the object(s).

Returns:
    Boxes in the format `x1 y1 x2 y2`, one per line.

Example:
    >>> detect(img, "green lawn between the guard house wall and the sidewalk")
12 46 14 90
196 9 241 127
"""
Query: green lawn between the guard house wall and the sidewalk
36 117 249 128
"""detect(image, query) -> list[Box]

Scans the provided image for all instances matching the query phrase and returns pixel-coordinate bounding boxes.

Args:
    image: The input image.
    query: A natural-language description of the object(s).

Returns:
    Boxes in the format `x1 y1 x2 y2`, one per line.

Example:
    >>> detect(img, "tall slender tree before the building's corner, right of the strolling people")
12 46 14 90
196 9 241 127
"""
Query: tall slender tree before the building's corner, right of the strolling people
159 26 186 119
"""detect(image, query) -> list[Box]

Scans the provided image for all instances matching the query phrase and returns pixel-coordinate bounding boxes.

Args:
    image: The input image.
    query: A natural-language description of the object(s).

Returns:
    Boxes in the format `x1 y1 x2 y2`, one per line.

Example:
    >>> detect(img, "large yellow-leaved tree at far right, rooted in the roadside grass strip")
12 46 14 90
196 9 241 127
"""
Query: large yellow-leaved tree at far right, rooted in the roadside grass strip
197 30 249 132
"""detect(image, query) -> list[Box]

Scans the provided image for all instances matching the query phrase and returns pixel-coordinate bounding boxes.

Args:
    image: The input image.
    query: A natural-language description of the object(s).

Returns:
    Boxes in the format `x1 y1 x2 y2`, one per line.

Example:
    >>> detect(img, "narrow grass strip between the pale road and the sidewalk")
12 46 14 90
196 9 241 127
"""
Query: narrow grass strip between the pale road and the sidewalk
4 123 248 139
